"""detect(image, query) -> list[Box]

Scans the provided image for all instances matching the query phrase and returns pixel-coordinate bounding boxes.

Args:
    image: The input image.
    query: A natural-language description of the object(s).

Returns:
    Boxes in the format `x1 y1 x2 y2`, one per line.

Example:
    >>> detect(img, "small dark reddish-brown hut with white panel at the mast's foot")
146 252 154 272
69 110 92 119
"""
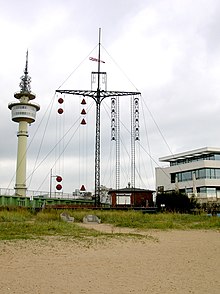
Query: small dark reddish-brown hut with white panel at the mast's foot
108 187 155 207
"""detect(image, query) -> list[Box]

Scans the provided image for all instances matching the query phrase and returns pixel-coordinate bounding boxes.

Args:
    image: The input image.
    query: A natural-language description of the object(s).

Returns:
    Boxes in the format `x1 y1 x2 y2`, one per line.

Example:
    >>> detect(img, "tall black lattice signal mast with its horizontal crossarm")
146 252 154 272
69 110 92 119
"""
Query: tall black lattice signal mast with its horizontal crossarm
56 28 141 207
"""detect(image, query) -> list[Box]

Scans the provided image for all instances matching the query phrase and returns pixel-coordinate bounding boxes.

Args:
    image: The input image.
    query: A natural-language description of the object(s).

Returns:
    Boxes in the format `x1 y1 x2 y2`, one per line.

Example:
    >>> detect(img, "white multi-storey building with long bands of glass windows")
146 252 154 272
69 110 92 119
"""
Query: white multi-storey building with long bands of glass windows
156 147 220 202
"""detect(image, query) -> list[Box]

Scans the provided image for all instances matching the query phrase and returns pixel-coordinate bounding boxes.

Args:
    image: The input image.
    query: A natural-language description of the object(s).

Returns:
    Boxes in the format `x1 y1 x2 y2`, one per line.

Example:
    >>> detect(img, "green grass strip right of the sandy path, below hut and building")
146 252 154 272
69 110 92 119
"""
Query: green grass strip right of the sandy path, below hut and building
69 211 220 230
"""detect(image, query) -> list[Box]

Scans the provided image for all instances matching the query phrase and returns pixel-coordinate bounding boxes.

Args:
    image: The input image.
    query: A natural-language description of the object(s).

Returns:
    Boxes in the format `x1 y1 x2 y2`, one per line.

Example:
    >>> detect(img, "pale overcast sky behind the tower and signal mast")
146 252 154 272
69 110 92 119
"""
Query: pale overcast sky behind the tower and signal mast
0 0 220 192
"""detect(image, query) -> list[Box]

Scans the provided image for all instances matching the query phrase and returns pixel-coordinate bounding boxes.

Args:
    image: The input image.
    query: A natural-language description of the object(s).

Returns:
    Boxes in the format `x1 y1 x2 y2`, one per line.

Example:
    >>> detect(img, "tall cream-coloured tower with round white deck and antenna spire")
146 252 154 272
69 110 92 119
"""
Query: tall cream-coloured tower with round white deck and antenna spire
8 52 40 197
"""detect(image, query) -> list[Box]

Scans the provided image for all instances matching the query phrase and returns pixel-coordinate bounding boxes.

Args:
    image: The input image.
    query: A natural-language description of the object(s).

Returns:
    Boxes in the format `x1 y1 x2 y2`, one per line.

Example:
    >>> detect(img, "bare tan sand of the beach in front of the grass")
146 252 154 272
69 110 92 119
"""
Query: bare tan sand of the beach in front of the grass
0 225 220 294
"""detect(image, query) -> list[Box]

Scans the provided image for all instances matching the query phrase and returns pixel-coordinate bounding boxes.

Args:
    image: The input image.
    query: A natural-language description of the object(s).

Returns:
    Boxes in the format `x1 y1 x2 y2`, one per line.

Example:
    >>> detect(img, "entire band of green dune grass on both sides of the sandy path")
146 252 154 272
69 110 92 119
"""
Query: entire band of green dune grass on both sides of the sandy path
0 210 220 240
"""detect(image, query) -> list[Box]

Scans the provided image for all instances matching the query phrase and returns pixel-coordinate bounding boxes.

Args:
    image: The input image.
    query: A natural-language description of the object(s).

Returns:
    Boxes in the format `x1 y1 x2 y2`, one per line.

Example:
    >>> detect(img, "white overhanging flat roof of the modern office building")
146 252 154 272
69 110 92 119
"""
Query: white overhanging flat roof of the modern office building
159 147 220 162
